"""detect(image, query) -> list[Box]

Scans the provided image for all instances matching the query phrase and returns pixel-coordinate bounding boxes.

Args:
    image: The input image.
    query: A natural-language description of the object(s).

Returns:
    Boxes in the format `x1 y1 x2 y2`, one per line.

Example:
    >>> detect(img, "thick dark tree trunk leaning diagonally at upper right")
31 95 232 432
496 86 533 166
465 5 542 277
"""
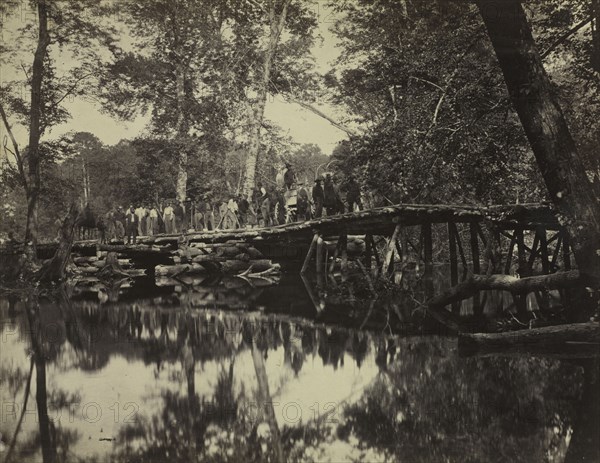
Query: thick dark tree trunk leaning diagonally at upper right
477 0 600 280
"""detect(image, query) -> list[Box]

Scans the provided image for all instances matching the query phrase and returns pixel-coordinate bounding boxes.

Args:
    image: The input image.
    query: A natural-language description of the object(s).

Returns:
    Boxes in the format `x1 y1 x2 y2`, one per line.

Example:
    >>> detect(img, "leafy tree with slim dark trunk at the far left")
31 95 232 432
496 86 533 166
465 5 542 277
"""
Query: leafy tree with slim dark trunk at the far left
0 0 112 255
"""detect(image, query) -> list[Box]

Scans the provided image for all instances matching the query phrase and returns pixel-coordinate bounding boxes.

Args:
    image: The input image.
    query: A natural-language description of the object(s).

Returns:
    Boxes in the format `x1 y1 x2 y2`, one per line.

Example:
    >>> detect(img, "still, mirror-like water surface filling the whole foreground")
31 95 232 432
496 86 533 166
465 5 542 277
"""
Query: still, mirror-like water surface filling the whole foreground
0 274 600 462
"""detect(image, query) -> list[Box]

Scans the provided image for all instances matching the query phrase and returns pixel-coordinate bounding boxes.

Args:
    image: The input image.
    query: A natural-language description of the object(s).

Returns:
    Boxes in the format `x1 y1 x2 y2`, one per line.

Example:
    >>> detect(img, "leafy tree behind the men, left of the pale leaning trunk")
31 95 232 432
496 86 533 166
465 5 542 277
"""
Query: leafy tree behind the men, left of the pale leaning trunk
101 0 234 200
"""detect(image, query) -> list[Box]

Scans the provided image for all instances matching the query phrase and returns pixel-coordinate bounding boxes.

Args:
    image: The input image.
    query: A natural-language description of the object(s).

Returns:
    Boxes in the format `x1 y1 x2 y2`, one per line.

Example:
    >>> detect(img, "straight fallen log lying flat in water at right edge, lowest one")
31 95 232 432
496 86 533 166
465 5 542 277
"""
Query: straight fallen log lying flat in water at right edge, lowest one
458 322 600 356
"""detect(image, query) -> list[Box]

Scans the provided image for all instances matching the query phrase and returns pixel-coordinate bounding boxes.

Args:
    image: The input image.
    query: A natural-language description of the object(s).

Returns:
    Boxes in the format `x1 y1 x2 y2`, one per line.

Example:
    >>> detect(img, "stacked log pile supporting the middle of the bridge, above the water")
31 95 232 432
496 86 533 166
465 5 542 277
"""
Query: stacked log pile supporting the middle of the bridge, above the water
154 240 280 277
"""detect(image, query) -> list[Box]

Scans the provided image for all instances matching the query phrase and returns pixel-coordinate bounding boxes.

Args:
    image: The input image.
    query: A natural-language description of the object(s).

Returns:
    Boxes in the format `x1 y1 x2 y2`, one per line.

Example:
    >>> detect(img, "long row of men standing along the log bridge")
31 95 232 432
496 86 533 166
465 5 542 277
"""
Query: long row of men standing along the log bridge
68 163 362 244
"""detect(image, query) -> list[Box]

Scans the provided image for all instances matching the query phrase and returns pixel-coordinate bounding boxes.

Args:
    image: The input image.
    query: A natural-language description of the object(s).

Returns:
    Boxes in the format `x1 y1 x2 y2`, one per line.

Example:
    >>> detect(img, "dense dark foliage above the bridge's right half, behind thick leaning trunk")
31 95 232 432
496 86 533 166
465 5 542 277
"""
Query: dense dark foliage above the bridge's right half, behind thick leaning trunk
326 0 600 204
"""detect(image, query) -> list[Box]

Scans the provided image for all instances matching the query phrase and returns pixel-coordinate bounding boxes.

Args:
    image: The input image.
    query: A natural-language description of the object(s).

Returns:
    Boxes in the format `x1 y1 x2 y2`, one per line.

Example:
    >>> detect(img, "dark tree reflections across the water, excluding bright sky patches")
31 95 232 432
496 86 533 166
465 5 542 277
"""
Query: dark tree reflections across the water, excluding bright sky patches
2 290 600 462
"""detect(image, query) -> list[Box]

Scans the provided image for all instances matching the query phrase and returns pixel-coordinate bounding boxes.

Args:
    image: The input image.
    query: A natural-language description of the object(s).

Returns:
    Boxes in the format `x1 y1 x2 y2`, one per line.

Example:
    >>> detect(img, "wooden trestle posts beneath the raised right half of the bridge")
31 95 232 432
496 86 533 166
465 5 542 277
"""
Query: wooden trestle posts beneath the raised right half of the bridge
301 218 571 313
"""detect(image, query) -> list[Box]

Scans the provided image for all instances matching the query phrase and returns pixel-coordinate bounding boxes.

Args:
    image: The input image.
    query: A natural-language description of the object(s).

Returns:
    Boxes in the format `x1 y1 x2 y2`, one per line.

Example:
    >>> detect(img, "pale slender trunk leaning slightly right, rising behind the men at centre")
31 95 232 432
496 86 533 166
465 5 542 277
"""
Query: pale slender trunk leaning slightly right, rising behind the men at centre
244 0 291 198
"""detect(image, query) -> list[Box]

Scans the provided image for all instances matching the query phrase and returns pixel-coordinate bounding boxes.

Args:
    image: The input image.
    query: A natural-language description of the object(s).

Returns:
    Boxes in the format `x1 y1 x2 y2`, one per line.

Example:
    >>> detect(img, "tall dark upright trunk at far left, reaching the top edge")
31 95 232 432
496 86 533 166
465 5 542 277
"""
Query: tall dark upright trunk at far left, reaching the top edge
25 0 50 256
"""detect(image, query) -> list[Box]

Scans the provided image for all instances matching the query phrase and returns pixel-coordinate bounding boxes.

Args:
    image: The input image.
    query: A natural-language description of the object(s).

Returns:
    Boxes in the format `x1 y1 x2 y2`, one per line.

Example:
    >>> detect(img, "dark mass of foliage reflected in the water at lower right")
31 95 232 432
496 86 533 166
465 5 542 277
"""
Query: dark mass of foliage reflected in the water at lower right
338 340 598 462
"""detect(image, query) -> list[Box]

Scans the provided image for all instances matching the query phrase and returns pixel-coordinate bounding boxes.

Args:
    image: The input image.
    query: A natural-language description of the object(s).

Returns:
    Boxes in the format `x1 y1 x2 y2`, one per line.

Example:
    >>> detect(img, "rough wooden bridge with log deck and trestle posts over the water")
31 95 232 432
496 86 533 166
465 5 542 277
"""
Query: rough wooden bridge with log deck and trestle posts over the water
31 204 571 284
